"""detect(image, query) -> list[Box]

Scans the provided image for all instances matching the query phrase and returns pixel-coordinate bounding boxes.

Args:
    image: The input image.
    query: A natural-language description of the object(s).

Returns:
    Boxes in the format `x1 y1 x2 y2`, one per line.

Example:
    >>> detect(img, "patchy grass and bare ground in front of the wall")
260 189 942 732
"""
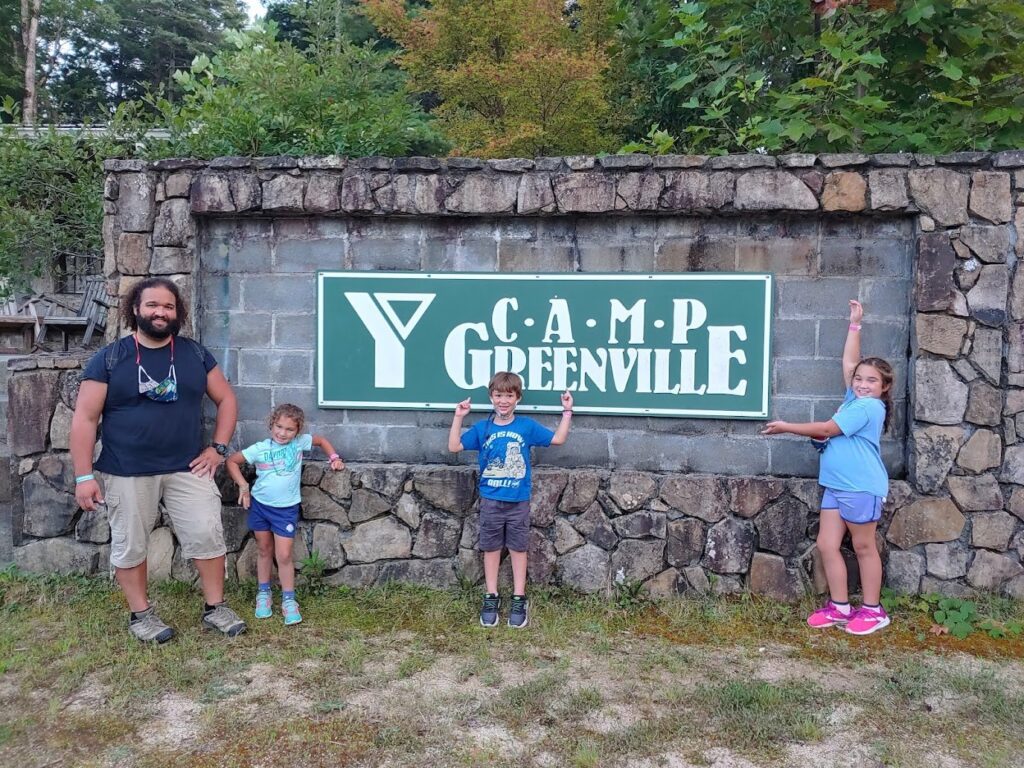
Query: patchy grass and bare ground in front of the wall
0 570 1024 768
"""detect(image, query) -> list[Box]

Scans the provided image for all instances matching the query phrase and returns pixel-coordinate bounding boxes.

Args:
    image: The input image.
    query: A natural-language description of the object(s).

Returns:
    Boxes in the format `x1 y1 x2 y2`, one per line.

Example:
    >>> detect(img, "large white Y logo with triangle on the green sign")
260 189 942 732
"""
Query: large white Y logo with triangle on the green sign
345 291 437 389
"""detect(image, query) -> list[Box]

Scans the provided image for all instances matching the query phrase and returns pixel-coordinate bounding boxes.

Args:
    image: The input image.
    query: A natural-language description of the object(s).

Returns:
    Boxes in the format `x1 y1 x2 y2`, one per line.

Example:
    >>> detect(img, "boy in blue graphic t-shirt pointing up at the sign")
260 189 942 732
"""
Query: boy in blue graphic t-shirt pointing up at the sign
449 371 572 629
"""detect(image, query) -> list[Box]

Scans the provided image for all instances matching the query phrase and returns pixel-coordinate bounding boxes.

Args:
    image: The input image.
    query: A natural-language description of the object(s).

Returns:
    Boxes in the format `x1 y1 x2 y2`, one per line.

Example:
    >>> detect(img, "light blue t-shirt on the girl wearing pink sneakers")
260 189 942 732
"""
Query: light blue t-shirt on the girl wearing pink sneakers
818 389 889 497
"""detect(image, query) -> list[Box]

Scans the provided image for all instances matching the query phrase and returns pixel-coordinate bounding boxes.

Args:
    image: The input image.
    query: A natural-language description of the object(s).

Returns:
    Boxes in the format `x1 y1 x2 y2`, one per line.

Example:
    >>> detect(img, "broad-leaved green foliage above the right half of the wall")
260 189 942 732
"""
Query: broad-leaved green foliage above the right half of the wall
618 0 1024 153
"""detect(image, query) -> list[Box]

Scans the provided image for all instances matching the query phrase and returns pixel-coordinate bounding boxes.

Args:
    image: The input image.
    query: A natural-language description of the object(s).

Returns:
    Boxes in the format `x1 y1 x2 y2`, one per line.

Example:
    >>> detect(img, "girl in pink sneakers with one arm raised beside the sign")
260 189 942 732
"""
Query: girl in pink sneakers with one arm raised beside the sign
762 299 893 635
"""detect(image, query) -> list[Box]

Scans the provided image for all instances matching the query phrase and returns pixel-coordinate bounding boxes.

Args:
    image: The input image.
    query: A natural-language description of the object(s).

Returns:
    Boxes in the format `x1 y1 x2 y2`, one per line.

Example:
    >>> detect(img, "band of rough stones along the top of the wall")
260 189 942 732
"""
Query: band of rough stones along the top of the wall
104 152 1024 221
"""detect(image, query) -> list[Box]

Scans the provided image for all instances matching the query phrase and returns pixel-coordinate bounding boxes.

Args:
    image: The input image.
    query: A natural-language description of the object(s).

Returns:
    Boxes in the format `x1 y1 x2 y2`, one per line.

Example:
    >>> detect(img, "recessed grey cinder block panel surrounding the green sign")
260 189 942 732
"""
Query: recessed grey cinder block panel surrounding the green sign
198 214 913 477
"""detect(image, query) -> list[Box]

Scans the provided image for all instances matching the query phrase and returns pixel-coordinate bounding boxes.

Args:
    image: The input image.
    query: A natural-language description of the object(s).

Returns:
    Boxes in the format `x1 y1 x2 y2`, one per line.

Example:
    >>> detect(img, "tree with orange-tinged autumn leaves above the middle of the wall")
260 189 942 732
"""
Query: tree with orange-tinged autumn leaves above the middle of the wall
362 0 617 157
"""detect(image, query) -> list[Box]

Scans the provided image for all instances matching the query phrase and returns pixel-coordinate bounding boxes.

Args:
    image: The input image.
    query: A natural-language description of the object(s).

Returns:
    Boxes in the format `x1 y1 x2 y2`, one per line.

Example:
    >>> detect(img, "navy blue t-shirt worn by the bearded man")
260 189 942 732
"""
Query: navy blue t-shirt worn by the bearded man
82 336 217 477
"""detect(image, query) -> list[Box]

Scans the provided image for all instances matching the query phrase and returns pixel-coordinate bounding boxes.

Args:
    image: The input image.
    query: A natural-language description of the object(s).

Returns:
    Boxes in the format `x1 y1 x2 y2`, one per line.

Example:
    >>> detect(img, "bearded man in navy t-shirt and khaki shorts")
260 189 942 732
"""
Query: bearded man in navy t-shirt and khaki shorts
71 278 246 643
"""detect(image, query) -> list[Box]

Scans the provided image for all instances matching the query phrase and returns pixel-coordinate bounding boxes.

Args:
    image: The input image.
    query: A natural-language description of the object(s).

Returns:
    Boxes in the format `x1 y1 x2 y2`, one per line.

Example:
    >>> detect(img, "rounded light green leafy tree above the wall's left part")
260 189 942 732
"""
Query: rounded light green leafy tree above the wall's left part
151 24 443 158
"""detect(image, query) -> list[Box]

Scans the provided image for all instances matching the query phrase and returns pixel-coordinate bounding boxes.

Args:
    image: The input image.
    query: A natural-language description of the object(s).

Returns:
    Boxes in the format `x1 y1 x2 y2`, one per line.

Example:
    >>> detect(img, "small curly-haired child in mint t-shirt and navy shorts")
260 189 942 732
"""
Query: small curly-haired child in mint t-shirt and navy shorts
226 402 345 625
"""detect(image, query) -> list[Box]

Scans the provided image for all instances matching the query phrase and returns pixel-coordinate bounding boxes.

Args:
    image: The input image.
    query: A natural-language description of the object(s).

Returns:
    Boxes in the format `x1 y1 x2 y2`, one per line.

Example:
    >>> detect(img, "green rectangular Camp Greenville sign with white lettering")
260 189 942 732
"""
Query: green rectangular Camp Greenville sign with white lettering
317 272 772 419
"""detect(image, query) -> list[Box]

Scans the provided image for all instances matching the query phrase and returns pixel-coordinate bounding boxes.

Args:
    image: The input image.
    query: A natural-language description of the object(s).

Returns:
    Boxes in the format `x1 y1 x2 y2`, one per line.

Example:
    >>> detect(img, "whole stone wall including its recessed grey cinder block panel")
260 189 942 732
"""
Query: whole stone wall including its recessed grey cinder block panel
10 152 1024 599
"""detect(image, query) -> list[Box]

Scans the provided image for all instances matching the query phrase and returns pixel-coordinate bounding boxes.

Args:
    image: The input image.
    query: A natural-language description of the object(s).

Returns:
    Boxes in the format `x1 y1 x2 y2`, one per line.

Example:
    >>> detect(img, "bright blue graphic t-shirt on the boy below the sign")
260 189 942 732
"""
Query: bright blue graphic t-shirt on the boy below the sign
462 416 555 502
